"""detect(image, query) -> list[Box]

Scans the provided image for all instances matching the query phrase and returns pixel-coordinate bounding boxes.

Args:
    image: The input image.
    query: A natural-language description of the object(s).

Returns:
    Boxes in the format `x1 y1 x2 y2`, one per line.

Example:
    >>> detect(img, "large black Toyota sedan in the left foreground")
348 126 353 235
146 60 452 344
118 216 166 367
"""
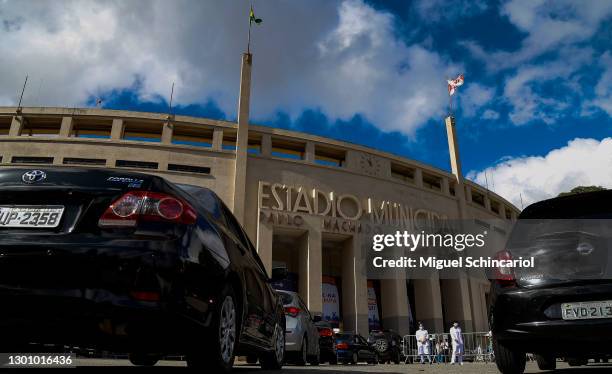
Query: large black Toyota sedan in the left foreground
0 168 285 371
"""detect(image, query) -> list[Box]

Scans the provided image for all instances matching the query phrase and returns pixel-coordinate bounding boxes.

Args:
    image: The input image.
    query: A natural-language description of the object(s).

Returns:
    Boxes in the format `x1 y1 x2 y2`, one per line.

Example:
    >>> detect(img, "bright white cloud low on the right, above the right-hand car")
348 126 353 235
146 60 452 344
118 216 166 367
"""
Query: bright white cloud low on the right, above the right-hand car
467 138 612 207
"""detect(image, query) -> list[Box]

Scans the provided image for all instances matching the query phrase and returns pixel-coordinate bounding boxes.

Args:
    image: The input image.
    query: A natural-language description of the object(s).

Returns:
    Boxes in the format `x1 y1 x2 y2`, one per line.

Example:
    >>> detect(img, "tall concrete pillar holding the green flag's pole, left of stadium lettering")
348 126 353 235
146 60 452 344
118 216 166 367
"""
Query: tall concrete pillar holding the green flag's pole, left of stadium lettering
233 53 253 224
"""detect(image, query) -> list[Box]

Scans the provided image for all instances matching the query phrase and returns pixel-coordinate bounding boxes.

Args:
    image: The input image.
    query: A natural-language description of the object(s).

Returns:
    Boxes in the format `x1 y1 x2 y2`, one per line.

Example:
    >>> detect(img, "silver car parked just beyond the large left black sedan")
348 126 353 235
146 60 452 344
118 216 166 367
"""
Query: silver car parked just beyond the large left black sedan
278 290 321 365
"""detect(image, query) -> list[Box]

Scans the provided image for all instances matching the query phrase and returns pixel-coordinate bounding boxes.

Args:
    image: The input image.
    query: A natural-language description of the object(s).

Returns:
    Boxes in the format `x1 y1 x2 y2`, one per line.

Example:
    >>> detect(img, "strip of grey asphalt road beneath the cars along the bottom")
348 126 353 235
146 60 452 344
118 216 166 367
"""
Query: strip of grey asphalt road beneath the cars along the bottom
5 359 612 374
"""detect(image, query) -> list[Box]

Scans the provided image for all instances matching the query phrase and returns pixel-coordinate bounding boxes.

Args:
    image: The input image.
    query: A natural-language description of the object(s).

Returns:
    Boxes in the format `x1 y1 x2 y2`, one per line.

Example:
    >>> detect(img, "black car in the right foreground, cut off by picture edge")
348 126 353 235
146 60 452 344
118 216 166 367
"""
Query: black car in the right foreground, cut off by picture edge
489 191 612 374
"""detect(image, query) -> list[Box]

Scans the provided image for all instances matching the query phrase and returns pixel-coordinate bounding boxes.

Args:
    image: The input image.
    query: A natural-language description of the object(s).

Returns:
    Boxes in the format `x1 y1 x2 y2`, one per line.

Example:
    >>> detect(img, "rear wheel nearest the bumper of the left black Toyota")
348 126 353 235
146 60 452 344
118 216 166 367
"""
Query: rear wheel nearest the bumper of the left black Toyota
187 285 241 373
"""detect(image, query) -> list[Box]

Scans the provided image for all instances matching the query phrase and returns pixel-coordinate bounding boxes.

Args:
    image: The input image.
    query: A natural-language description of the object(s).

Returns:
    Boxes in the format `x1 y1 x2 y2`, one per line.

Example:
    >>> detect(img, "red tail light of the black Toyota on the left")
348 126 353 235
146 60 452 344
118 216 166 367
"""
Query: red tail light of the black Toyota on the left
98 191 197 228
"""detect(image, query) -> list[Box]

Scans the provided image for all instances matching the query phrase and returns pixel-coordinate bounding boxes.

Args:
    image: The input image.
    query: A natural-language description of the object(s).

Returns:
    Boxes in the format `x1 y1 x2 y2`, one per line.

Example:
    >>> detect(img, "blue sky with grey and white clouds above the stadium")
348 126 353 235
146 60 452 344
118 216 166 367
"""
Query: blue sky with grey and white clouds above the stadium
0 0 612 208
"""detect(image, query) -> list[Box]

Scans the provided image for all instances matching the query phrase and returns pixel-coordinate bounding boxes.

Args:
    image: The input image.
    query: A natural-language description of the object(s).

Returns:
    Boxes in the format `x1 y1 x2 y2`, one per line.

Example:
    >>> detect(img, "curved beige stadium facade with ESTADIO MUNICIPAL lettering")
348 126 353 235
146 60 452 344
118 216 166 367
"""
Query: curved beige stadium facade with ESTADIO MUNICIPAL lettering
0 107 518 333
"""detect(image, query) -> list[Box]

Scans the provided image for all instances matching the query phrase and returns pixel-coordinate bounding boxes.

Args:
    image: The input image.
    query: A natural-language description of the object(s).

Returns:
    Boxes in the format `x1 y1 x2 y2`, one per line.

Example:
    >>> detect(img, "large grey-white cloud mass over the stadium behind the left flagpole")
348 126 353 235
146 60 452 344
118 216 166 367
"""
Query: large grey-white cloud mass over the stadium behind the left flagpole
0 0 461 134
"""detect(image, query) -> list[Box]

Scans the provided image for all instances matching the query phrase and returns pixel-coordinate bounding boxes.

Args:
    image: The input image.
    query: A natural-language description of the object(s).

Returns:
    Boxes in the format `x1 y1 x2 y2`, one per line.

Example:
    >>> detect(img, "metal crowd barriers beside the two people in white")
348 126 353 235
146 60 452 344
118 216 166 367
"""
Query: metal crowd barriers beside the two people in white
402 332 495 363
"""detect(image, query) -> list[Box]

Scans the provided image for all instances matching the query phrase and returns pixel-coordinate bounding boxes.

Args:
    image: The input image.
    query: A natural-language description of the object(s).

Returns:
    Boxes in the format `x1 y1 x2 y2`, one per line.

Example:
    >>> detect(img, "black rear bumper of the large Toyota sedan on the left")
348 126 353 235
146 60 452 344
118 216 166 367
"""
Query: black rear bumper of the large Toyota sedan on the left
0 287 202 353
